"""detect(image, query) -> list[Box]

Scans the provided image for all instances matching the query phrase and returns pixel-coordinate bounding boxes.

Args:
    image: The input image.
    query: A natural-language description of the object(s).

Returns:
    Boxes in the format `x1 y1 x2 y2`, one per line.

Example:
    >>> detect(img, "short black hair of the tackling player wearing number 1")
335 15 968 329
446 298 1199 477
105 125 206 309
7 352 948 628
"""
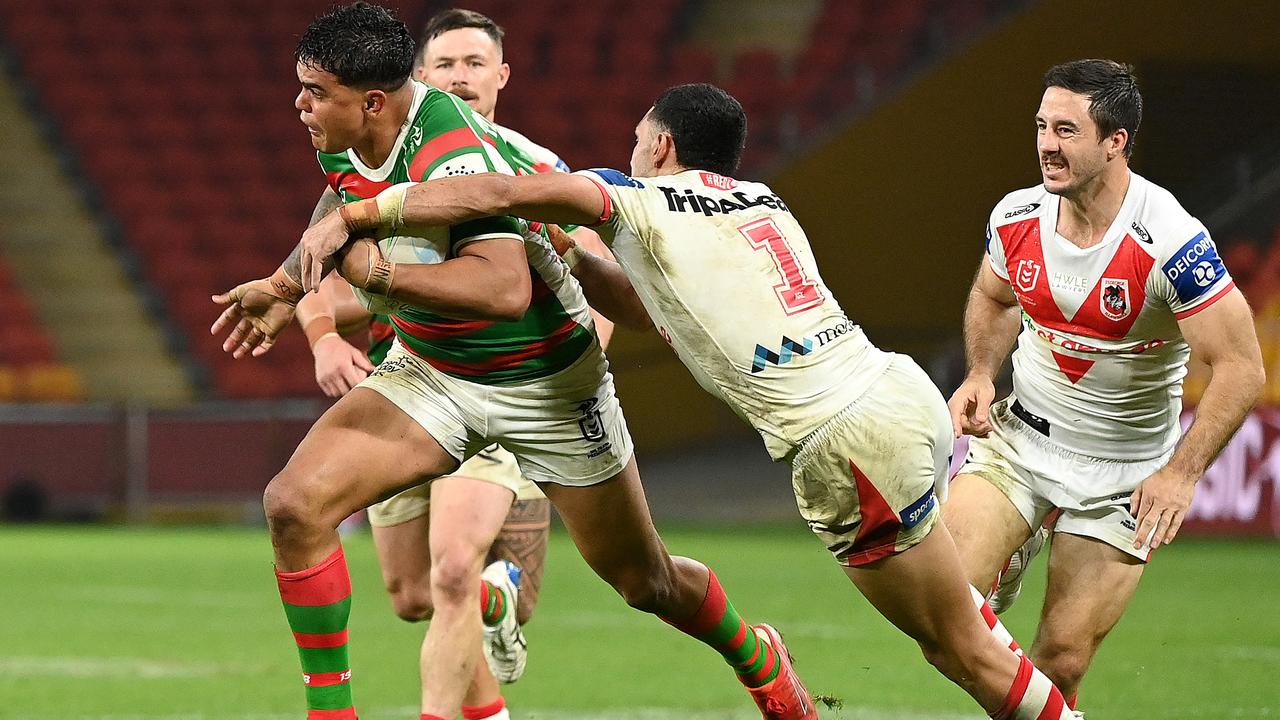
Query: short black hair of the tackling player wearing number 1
652 83 746 176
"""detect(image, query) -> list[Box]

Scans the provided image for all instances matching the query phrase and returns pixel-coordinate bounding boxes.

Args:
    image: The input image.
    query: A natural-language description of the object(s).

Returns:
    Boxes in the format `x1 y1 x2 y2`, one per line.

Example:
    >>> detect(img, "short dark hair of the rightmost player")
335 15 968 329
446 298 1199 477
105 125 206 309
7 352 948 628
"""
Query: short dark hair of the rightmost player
1044 59 1142 158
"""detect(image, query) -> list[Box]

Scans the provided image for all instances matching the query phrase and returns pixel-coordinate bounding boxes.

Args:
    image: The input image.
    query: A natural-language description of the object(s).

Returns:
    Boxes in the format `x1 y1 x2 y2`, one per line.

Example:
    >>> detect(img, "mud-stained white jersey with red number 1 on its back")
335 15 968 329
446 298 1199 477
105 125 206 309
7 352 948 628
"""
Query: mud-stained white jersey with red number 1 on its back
580 169 892 460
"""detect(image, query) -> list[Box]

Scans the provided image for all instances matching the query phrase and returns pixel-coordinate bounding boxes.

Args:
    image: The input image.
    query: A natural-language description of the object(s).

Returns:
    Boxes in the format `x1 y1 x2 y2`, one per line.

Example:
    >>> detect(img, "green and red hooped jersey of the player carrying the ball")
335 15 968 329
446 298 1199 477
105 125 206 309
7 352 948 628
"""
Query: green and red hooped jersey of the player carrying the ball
319 81 594 384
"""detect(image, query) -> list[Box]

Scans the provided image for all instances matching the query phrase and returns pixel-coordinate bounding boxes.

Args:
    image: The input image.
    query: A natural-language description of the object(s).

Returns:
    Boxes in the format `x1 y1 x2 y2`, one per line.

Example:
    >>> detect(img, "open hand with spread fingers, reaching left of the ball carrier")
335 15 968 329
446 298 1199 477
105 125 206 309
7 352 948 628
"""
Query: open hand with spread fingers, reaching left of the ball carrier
209 269 302 359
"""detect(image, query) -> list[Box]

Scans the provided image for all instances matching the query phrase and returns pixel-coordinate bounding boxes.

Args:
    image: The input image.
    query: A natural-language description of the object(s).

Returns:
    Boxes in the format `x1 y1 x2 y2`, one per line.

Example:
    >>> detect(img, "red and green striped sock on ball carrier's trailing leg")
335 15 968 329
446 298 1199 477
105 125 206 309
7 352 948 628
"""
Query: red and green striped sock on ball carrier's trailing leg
663 568 782 688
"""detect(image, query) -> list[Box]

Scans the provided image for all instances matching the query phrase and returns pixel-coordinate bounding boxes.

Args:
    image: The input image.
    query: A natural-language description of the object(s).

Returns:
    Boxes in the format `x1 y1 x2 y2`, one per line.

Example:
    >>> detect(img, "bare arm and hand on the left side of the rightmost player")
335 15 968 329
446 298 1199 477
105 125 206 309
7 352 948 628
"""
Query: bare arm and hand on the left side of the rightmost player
947 258 1021 437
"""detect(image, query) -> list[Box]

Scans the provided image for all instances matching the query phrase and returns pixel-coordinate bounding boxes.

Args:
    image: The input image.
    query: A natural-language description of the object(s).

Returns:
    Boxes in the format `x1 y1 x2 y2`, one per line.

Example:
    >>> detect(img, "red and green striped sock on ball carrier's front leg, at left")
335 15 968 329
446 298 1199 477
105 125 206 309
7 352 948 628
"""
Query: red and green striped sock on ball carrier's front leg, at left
275 546 356 720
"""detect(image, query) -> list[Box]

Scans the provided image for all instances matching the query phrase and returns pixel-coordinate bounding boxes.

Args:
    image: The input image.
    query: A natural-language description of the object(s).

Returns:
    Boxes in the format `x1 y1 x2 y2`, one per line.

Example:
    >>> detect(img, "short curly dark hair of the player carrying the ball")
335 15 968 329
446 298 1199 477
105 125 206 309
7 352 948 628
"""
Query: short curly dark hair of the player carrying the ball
293 1 413 91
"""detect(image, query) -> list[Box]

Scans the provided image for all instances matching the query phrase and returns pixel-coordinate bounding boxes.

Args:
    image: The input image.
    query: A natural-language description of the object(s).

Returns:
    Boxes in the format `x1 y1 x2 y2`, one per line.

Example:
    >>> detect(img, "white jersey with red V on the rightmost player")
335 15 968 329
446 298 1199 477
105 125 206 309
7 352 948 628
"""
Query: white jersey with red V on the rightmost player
987 173 1235 460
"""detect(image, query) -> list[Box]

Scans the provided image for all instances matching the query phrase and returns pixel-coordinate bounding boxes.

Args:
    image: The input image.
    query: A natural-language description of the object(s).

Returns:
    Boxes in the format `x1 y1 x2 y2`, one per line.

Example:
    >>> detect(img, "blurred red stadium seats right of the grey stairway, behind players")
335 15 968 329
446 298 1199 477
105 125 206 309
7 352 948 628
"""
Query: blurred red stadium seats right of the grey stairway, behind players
0 0 1007 397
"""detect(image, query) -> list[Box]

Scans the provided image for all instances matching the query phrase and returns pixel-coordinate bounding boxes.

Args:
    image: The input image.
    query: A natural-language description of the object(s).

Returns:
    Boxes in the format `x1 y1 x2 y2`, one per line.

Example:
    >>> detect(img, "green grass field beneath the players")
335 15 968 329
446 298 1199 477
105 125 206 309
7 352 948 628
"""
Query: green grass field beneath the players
0 521 1280 720
